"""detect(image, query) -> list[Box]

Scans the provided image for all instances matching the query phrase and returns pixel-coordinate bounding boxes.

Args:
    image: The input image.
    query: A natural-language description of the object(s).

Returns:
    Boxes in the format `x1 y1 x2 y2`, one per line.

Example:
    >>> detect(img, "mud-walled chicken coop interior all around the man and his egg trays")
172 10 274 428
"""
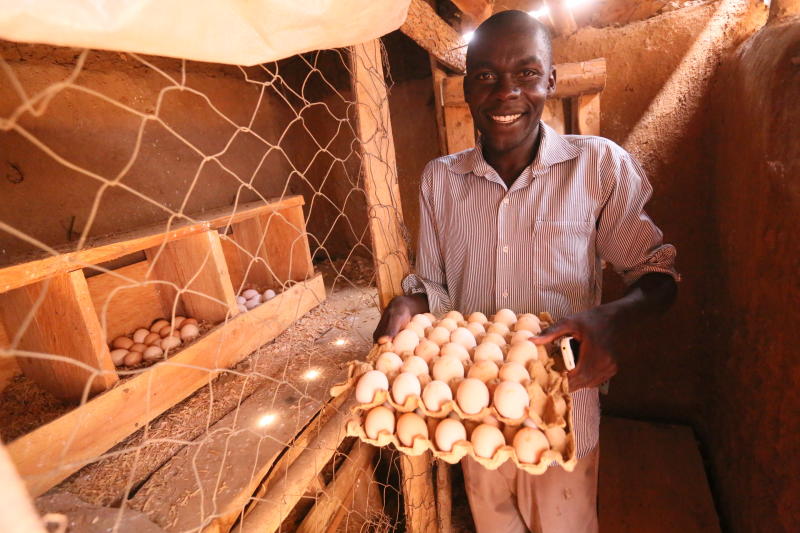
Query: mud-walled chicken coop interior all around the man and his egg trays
0 0 800 533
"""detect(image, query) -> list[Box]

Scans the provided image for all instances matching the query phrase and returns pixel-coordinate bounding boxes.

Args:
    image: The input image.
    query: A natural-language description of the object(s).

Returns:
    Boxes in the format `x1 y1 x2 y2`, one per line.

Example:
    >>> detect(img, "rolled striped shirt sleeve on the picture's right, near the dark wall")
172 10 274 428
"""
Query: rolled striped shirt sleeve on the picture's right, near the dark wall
597 153 680 285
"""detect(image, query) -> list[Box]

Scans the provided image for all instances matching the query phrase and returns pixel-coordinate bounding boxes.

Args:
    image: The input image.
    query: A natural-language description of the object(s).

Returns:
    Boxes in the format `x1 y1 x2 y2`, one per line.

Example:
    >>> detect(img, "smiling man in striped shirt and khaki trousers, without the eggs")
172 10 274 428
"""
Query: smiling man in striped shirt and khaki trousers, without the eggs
375 11 678 533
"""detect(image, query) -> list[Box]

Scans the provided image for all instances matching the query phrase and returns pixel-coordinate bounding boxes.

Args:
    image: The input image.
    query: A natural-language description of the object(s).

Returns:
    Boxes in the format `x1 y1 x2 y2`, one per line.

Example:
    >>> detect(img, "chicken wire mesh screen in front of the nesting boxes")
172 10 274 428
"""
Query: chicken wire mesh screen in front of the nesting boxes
0 35 410 531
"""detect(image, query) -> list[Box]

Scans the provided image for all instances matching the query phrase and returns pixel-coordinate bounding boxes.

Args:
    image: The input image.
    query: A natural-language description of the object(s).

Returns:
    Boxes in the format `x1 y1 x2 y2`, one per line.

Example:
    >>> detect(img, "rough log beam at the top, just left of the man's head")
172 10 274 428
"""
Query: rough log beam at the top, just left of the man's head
400 0 467 72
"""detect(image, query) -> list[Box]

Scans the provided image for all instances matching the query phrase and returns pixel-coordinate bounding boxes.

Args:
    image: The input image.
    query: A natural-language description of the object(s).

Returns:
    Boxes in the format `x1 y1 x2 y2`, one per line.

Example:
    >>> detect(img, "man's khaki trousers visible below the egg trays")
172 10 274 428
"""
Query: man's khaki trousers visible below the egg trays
461 447 599 533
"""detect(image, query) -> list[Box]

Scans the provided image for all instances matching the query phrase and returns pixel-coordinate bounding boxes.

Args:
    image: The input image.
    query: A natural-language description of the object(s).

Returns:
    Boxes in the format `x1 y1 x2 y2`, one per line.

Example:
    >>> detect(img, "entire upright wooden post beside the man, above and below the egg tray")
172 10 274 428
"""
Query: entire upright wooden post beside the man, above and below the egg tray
351 38 436 533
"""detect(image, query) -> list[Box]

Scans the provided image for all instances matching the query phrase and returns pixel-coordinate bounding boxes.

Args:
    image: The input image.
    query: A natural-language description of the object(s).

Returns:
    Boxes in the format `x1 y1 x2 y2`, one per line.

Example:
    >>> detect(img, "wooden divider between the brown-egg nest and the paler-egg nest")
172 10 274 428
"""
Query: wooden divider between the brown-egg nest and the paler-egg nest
145 230 239 324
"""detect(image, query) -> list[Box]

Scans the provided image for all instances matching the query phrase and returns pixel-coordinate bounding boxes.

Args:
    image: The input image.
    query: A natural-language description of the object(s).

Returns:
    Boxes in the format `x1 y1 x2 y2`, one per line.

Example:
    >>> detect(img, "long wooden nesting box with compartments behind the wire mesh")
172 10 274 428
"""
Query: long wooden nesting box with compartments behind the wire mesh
0 196 325 494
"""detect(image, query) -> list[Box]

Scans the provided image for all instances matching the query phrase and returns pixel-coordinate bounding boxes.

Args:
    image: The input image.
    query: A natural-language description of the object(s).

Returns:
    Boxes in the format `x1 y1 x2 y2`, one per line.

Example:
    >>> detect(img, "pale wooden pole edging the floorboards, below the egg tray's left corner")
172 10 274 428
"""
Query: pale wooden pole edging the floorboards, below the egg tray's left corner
237 395 356 533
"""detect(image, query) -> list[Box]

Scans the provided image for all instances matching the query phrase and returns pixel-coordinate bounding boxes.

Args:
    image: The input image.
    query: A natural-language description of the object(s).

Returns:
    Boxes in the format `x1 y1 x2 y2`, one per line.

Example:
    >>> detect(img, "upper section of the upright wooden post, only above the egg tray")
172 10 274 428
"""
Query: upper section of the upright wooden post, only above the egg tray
351 39 412 307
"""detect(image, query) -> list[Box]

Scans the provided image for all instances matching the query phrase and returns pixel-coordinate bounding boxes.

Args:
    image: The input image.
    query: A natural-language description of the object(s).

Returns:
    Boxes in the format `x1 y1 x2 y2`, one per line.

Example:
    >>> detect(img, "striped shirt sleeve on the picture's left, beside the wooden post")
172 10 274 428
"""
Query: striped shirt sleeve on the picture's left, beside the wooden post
402 164 453 315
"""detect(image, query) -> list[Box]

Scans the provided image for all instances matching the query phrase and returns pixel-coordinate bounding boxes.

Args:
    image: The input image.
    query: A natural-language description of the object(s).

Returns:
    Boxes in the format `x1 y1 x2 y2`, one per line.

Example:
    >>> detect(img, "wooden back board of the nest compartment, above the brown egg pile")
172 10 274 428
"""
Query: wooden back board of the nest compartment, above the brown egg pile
86 261 169 340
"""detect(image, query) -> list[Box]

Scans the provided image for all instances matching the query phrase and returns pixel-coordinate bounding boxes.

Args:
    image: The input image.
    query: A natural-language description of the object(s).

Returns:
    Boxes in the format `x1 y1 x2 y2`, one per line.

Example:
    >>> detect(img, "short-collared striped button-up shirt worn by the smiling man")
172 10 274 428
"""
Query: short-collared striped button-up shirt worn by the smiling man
403 123 678 457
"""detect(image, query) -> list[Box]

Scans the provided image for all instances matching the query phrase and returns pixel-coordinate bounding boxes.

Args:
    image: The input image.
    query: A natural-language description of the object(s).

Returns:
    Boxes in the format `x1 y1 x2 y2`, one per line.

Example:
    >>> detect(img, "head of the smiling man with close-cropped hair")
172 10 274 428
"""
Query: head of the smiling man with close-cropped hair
464 10 556 152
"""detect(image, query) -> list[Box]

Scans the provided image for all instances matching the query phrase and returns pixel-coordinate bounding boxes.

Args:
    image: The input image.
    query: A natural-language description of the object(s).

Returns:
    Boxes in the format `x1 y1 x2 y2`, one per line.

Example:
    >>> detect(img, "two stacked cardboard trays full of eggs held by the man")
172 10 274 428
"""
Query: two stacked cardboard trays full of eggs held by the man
331 309 577 474
